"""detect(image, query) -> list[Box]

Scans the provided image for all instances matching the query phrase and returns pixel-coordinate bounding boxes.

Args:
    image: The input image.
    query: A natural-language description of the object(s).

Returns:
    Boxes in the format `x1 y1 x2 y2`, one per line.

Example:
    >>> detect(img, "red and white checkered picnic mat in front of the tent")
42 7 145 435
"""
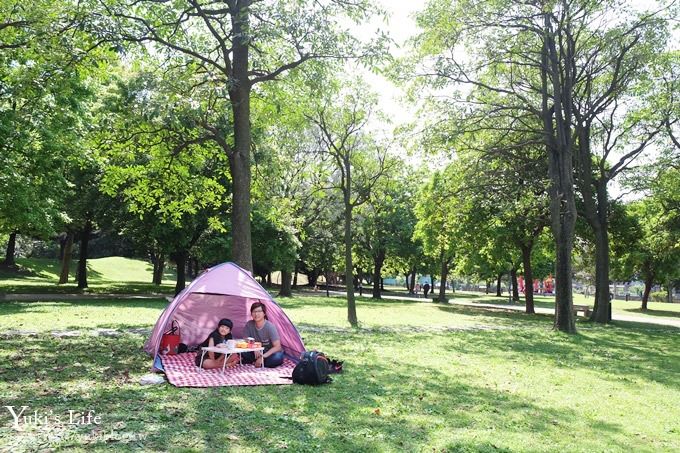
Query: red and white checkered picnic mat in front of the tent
161 352 295 387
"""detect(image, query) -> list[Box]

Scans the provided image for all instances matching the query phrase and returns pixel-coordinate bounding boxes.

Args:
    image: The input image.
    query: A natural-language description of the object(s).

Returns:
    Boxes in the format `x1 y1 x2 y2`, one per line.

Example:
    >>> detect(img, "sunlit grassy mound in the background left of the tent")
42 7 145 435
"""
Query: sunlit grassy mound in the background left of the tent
0 256 175 294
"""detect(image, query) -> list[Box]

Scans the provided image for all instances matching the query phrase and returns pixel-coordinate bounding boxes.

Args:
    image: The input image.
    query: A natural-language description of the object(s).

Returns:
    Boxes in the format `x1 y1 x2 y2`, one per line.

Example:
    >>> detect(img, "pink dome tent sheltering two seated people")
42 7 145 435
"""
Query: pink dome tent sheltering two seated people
144 263 305 368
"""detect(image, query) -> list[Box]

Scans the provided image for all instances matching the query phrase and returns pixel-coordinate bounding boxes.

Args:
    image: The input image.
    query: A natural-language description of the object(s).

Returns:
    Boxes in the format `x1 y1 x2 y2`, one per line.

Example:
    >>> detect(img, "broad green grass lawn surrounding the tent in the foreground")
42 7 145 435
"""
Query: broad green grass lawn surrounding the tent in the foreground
0 297 680 452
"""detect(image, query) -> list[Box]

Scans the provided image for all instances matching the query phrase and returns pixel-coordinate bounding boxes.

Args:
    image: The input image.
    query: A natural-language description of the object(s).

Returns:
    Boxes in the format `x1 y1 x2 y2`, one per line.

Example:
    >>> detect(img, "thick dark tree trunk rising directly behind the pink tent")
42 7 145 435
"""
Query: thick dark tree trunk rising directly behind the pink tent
227 2 253 273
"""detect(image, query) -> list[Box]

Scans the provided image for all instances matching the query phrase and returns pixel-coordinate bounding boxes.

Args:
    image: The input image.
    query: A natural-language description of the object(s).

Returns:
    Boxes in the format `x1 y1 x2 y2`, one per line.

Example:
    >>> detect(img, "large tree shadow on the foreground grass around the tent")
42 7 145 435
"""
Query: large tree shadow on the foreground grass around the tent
0 333 625 451
